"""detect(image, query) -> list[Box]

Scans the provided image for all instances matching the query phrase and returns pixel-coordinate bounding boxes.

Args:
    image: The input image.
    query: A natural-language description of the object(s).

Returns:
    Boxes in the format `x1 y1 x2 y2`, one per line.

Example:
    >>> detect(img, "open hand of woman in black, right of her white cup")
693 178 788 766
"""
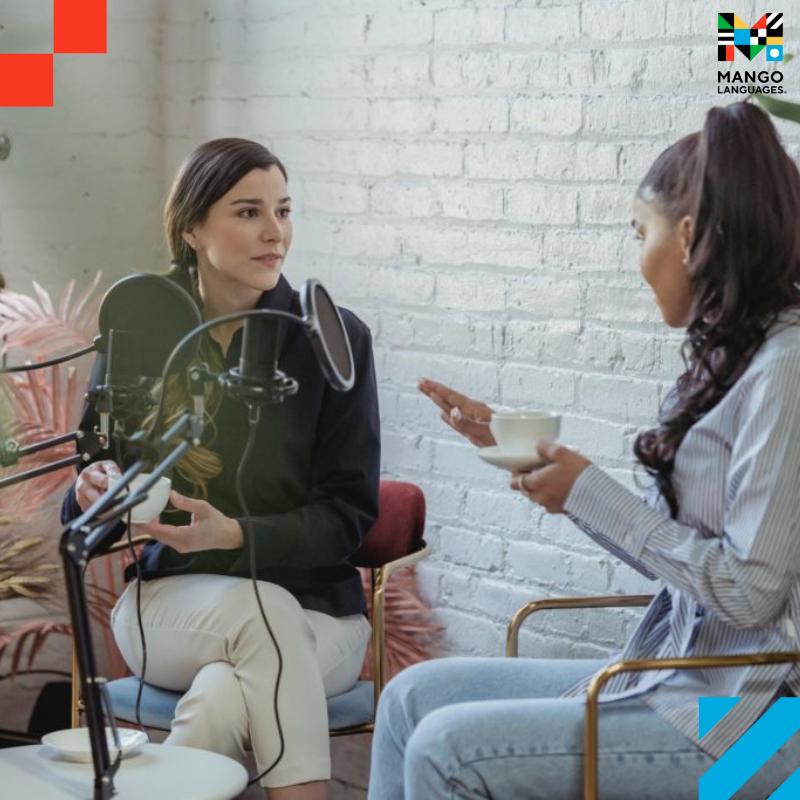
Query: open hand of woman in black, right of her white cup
133 490 244 553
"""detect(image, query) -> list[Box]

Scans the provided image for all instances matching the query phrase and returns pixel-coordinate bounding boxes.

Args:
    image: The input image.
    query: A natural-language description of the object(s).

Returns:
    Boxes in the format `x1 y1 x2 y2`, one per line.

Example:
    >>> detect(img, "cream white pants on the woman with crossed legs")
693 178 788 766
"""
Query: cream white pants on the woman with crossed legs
111 575 370 787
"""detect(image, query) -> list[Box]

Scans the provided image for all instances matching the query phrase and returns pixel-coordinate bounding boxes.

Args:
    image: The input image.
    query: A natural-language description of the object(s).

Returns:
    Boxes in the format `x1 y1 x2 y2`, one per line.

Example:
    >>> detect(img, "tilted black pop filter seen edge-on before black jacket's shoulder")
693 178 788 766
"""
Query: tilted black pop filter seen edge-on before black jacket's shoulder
300 278 355 392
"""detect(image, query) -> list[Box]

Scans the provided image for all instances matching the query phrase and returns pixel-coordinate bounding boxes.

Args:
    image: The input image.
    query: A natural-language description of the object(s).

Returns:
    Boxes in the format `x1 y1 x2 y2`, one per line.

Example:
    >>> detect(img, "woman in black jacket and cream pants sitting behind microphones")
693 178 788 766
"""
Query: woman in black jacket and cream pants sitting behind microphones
62 139 380 799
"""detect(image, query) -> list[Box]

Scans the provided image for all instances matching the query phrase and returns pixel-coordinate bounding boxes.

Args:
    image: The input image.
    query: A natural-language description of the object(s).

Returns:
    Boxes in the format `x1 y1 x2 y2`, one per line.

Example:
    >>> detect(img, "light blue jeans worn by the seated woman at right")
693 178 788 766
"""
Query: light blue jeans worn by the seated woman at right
369 658 800 800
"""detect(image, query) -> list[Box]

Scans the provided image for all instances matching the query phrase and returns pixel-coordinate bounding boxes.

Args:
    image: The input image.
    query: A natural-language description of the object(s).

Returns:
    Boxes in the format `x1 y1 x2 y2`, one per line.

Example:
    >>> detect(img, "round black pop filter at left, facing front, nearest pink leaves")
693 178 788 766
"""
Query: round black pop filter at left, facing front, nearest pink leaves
95 273 202 378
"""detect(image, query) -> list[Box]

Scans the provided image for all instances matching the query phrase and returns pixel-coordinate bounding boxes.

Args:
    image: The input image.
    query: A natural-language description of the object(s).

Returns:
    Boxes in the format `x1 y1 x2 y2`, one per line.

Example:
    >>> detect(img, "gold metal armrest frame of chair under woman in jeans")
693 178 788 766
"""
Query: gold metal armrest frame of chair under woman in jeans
506 594 800 800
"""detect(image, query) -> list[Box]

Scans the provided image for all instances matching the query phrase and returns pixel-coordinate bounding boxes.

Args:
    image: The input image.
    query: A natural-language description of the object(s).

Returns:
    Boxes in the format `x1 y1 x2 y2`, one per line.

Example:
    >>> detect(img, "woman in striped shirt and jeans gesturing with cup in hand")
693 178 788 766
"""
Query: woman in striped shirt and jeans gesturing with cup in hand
370 103 800 800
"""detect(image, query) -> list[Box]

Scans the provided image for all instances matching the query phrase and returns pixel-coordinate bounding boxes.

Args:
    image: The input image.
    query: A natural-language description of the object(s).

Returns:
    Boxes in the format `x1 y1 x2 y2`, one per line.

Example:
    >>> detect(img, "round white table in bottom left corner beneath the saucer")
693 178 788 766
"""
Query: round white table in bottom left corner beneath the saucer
0 744 247 800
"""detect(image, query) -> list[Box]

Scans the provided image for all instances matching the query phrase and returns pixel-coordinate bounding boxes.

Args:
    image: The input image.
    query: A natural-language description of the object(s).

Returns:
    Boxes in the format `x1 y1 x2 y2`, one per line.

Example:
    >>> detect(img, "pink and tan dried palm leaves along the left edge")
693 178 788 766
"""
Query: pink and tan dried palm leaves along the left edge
0 272 110 675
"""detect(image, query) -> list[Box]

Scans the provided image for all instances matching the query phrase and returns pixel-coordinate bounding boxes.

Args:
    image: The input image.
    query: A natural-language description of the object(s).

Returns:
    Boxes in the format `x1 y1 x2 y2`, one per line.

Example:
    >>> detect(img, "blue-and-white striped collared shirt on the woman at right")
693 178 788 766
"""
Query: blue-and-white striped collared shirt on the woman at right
564 309 800 758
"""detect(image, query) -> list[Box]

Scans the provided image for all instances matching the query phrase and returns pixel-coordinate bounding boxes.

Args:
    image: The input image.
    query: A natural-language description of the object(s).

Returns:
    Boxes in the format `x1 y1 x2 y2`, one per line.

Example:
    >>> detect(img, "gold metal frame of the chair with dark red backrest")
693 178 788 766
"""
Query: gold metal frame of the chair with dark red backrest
70 536 428 736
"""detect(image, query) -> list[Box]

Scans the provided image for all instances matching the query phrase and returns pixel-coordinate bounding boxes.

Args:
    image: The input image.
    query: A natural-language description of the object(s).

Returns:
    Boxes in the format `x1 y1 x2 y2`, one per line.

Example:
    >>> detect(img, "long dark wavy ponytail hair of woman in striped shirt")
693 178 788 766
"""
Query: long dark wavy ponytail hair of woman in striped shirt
634 103 800 518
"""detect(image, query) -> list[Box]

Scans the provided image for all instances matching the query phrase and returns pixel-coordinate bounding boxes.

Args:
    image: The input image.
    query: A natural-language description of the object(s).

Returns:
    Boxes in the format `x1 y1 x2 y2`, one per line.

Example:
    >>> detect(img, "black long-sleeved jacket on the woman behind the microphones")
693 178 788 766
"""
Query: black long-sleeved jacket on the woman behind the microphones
61 276 380 616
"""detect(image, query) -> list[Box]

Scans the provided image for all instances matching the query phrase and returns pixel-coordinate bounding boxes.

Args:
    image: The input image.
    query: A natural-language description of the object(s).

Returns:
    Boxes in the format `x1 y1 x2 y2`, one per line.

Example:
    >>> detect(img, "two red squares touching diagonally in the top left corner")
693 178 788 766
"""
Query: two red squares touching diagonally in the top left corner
0 0 106 106
